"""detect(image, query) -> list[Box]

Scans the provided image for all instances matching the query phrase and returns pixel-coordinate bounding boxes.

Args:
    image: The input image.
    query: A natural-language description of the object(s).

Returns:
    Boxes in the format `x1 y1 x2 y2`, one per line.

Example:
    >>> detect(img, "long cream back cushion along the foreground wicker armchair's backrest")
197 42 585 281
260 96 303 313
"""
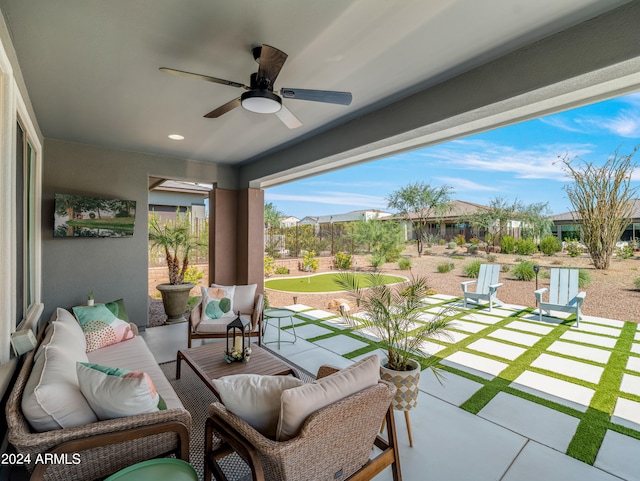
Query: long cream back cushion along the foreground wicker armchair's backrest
276 356 380 441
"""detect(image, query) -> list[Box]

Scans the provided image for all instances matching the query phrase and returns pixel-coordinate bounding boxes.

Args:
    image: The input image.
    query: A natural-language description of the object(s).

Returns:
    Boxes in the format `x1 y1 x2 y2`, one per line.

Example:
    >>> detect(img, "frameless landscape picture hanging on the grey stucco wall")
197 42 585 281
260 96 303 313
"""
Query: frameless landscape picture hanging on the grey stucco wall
53 194 136 237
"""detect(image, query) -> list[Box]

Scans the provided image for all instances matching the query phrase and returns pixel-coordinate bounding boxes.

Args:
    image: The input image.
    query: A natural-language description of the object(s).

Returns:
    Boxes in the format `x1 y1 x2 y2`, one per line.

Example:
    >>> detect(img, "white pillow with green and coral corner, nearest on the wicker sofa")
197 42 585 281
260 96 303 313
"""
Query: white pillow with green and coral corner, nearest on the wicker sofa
76 362 166 420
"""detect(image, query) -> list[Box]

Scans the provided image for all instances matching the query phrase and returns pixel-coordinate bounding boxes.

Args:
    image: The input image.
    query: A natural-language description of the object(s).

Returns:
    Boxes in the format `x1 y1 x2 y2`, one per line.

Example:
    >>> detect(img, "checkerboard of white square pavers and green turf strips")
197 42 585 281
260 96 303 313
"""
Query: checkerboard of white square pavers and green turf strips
285 295 640 464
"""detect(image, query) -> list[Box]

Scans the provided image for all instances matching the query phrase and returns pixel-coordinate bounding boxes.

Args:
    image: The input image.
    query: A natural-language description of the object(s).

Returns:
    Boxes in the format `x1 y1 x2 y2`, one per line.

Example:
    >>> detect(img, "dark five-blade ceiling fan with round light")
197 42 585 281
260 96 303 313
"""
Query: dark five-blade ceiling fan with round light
160 45 351 129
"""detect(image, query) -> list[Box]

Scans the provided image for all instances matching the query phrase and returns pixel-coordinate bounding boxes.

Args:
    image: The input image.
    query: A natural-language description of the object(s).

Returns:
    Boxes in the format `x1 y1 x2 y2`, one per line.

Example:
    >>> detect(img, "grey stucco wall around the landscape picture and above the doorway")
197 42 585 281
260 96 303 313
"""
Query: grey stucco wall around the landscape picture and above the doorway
42 139 218 326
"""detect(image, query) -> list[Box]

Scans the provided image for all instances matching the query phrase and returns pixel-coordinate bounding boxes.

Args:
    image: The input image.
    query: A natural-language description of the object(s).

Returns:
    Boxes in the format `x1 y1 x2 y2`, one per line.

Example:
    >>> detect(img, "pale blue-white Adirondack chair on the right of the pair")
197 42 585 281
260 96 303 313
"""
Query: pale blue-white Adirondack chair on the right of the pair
535 267 587 327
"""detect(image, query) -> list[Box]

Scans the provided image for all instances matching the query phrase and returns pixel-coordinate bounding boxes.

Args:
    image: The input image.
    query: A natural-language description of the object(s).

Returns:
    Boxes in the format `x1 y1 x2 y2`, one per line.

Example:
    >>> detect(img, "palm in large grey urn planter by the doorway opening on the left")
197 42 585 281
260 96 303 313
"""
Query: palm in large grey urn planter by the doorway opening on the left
149 212 200 323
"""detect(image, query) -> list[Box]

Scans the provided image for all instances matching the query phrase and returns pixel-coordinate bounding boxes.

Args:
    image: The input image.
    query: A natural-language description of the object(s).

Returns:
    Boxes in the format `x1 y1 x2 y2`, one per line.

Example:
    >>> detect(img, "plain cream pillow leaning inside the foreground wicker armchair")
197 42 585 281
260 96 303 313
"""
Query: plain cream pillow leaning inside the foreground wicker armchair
211 374 304 438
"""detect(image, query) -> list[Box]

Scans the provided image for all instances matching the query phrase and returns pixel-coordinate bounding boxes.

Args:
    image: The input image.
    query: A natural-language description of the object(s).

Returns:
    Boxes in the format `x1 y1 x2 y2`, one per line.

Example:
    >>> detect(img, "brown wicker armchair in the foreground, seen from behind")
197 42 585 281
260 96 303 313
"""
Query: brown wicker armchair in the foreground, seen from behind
205 368 402 481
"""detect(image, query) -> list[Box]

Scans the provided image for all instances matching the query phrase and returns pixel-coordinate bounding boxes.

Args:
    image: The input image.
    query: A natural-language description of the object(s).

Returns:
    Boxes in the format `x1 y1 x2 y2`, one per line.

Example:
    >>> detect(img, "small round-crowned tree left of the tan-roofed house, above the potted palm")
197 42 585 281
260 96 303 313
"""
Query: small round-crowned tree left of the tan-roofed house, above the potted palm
387 182 453 256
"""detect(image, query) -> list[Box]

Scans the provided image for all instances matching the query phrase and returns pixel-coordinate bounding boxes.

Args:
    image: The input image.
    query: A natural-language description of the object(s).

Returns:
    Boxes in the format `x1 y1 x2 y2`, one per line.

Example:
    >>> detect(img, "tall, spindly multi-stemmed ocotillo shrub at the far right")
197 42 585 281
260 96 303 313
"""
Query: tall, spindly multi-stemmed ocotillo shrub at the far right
560 147 638 269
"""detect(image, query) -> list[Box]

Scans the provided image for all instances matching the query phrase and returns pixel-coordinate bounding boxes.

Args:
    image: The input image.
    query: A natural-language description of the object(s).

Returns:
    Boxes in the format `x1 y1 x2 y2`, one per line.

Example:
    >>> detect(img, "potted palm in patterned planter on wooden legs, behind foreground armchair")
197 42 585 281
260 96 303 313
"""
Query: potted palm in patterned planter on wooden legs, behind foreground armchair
336 272 457 440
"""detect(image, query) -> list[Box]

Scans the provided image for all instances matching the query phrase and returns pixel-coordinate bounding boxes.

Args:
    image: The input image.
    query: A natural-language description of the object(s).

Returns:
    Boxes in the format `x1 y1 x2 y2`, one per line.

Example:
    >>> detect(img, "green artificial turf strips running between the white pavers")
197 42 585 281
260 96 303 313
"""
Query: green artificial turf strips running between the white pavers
284 299 640 464
